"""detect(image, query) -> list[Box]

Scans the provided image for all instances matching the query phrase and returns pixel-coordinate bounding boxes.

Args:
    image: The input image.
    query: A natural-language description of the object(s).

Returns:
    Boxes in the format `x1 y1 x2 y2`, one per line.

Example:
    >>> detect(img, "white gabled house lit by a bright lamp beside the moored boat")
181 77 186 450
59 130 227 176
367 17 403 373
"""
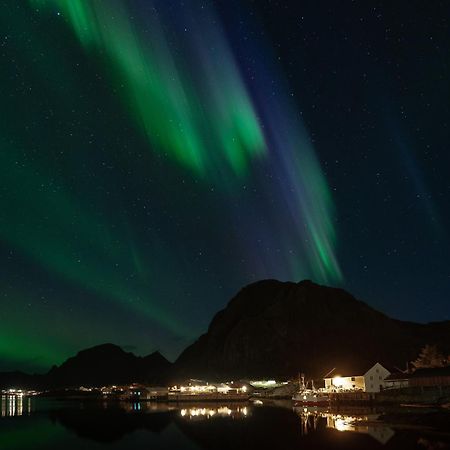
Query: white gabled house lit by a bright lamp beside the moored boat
324 363 390 392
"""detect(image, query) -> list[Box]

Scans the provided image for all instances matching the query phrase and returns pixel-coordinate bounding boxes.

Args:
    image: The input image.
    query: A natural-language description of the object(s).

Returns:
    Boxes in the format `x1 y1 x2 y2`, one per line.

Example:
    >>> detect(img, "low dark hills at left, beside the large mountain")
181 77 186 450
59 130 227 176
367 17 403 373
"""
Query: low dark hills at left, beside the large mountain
0 344 172 389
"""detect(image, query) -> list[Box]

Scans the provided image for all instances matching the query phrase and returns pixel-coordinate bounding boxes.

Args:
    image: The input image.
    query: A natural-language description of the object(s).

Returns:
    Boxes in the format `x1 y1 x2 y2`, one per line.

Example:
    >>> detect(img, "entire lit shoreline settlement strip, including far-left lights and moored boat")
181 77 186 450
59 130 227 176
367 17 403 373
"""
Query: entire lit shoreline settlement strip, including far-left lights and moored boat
2 346 450 407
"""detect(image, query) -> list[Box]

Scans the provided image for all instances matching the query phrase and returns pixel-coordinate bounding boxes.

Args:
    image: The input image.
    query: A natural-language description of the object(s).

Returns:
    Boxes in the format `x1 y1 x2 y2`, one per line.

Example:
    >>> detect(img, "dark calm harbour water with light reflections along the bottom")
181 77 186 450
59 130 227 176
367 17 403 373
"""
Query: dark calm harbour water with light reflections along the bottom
0 397 450 450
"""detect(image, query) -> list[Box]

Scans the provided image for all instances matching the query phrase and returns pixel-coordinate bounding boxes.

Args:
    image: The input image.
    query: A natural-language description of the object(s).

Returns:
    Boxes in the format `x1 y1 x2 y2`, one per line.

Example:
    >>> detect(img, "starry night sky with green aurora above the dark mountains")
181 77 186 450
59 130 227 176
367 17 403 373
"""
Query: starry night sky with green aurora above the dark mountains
0 0 450 372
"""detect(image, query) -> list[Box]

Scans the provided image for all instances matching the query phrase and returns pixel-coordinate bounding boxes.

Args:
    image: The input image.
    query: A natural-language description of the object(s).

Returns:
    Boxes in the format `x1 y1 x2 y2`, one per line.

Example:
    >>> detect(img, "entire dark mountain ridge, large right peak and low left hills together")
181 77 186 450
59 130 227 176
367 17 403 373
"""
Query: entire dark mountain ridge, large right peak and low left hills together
0 279 450 388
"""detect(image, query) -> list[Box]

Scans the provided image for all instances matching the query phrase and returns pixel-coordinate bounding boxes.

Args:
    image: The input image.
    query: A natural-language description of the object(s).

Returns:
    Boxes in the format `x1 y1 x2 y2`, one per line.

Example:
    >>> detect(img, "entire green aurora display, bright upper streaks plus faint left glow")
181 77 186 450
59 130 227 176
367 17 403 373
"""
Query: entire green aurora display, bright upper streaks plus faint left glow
0 0 342 366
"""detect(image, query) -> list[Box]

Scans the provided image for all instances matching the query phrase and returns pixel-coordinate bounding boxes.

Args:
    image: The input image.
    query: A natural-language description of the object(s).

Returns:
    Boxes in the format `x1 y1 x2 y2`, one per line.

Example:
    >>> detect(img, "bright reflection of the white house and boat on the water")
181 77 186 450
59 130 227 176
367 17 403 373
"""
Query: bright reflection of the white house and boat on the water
293 407 395 445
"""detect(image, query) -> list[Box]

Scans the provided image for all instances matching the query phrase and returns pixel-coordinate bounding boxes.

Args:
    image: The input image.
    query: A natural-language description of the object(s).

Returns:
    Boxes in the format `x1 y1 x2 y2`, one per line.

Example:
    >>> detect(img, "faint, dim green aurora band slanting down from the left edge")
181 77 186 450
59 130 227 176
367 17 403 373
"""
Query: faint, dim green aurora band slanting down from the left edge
0 143 186 333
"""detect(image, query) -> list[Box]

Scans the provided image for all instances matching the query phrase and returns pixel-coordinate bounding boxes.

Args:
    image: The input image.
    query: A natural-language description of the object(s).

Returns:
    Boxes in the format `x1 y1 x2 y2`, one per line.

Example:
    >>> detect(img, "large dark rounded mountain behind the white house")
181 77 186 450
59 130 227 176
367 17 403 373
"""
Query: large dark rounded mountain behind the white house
176 280 450 378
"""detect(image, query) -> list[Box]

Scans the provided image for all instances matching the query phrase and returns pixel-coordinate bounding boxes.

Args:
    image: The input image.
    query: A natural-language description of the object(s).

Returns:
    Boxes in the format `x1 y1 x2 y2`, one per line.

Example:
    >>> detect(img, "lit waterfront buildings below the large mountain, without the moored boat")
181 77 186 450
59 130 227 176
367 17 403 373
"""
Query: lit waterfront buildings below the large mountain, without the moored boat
100 362 450 406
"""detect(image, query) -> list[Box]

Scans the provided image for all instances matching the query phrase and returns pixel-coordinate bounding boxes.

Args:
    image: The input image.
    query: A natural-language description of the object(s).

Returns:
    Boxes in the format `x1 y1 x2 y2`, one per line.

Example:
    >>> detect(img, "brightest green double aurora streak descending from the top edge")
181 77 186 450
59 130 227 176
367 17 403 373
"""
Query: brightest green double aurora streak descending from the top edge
31 0 266 177
